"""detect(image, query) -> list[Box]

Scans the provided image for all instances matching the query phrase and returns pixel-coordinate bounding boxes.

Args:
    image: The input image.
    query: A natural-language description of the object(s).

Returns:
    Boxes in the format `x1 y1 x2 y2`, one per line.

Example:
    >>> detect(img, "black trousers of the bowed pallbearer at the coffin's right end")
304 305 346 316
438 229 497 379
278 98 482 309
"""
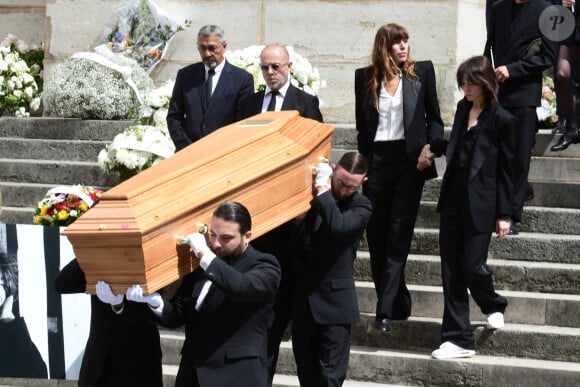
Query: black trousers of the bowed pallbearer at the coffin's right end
292 307 351 387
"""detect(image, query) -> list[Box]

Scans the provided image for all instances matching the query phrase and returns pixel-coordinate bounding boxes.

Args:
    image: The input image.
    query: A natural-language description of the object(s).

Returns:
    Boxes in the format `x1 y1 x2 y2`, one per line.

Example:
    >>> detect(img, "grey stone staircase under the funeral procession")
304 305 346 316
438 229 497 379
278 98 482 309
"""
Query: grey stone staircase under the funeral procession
0 118 580 387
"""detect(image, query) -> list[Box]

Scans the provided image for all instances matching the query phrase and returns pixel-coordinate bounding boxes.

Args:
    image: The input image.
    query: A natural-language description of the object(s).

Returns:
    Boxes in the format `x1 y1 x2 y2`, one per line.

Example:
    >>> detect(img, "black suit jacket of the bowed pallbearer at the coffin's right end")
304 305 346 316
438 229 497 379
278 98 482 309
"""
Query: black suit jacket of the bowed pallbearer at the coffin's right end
292 191 371 324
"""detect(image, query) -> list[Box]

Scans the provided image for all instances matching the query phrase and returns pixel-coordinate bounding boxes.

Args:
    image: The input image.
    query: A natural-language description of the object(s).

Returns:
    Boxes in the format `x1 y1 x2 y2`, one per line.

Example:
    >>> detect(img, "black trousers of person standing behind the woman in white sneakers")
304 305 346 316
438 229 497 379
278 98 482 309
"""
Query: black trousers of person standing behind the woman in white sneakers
505 106 538 222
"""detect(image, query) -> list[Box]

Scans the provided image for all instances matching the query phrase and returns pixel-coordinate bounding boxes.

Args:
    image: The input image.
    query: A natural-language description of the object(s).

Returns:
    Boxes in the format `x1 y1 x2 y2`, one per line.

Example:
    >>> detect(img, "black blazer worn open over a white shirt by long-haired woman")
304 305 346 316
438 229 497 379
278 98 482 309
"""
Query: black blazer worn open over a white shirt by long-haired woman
354 61 443 179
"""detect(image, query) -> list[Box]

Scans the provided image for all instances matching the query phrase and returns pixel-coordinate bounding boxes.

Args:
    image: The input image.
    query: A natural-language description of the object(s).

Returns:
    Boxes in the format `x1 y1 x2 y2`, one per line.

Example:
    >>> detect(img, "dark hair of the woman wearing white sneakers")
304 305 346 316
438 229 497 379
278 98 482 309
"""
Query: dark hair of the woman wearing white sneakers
457 56 499 107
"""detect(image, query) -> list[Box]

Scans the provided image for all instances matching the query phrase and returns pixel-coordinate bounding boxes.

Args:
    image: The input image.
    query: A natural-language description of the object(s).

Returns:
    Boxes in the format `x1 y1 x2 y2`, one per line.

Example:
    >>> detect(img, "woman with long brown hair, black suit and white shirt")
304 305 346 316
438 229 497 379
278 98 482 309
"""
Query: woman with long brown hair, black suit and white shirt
355 24 443 333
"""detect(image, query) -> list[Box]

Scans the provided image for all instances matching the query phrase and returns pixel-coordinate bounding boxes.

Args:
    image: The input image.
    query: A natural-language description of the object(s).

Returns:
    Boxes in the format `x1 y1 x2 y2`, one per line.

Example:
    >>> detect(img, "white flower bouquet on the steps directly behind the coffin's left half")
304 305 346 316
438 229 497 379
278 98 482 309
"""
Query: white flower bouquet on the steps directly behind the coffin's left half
98 125 175 180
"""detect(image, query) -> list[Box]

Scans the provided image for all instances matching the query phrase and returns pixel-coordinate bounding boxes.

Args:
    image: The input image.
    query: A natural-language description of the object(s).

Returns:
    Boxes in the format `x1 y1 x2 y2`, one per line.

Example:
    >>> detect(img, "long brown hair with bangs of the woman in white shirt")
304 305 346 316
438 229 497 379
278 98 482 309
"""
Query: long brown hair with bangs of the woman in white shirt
367 23 417 109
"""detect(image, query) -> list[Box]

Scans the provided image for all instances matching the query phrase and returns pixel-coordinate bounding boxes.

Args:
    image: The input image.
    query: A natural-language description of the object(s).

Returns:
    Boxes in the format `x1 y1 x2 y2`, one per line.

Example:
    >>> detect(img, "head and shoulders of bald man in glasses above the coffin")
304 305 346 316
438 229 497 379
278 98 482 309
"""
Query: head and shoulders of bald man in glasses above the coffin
238 43 322 122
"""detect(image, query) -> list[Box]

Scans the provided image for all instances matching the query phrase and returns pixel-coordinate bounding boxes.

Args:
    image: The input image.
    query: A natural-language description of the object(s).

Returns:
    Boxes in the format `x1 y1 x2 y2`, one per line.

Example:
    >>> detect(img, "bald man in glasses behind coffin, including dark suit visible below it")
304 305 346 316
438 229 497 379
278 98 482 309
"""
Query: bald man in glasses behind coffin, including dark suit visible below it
238 44 322 380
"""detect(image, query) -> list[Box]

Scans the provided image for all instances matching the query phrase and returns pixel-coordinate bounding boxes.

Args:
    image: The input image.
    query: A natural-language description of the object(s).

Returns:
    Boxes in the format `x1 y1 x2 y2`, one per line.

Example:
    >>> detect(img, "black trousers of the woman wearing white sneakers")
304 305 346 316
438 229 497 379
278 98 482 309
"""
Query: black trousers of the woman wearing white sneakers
439 167 507 349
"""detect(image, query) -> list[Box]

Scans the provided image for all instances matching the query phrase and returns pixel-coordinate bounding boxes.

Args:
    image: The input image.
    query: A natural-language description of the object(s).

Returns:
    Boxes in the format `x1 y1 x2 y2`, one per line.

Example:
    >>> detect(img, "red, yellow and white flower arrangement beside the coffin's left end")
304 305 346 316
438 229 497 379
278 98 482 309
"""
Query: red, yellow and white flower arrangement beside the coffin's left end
33 185 103 227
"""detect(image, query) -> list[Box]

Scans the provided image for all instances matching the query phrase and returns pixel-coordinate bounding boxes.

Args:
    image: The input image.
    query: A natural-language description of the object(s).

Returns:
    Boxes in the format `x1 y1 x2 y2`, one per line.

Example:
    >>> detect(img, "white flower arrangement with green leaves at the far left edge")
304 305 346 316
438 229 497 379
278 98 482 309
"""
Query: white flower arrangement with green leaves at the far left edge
0 35 41 117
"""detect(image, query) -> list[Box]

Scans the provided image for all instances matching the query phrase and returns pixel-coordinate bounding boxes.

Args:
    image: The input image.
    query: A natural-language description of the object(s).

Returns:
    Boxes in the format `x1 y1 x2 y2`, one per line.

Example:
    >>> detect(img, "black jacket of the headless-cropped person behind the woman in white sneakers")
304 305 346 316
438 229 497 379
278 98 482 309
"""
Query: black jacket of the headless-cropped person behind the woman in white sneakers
484 0 557 108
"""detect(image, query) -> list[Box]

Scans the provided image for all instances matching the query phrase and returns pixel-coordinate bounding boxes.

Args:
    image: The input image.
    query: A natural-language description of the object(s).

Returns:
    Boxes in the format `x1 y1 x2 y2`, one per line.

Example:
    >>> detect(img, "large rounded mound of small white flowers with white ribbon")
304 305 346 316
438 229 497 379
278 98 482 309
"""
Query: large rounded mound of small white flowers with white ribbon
42 47 154 120
